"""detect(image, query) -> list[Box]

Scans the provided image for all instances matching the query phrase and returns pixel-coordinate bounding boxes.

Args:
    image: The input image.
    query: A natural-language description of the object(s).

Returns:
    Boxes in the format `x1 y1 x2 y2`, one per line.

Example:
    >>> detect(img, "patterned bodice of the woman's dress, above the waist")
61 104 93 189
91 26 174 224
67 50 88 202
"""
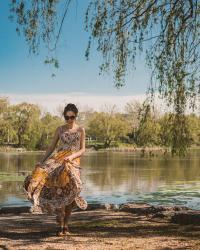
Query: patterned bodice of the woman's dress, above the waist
58 126 81 151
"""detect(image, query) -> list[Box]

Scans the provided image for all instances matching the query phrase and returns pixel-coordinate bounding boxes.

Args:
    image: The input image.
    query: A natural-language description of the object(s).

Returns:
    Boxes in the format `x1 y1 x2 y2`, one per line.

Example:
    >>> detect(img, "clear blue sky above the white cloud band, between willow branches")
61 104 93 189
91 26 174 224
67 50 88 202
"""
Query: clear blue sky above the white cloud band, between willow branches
0 0 149 95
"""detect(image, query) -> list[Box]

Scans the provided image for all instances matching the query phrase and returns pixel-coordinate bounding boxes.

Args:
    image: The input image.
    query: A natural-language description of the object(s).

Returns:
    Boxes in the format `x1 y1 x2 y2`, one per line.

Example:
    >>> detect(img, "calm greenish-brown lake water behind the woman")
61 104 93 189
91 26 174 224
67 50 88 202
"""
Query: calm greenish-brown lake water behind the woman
0 150 200 209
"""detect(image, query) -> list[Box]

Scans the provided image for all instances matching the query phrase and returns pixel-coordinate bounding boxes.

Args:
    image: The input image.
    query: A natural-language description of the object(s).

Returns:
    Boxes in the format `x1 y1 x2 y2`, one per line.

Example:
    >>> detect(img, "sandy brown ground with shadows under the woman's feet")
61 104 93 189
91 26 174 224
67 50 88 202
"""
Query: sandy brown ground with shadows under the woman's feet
0 210 200 250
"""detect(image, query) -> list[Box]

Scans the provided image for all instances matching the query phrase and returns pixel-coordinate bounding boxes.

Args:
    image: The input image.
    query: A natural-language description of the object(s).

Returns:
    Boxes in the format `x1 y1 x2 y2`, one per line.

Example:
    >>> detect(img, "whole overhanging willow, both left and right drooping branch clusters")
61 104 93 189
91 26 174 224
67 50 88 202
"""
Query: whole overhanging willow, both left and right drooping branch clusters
11 0 200 152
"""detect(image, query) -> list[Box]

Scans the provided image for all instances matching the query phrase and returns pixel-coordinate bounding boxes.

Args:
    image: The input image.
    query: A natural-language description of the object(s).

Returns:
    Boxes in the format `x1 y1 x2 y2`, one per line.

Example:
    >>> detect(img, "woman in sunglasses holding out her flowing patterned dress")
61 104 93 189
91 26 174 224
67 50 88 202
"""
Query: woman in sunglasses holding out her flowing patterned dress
23 103 87 236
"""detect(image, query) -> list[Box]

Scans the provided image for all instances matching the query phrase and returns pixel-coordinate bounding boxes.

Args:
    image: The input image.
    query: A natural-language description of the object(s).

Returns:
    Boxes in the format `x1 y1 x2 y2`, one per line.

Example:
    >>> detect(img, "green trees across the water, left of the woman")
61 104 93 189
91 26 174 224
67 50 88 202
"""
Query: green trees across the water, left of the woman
0 98 62 150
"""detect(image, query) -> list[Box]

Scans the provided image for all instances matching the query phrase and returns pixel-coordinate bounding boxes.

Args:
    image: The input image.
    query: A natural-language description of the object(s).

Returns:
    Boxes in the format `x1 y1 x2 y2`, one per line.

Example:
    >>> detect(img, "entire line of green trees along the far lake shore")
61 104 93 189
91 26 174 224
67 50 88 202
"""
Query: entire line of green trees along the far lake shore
0 98 200 154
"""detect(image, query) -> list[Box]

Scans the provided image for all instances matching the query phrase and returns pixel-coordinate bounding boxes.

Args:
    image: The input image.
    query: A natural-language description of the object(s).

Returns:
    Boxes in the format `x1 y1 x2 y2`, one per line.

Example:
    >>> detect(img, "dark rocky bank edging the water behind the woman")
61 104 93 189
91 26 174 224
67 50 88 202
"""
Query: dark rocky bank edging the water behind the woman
0 202 200 225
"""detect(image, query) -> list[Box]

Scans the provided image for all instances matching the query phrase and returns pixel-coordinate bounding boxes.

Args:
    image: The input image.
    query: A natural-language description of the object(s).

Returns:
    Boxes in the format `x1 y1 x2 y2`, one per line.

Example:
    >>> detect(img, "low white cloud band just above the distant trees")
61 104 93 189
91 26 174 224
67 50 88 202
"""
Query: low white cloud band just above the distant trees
0 92 148 114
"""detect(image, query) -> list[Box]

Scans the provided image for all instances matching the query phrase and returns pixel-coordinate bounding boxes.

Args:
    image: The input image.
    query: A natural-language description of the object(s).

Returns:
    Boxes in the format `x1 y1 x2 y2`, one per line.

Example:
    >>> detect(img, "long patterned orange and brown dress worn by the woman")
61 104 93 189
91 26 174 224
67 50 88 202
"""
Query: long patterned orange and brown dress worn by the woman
23 127 87 215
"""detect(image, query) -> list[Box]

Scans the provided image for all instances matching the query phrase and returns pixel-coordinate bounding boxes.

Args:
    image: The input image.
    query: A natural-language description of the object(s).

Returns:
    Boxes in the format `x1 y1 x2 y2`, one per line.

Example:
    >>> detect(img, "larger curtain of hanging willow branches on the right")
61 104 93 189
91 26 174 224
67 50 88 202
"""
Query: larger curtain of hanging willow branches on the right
85 0 200 155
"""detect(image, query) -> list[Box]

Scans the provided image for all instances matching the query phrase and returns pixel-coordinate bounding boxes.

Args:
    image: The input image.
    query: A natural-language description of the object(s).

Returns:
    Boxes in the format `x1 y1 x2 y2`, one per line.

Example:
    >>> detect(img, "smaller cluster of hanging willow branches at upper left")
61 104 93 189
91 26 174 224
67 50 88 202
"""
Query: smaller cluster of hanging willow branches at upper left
9 0 72 64
